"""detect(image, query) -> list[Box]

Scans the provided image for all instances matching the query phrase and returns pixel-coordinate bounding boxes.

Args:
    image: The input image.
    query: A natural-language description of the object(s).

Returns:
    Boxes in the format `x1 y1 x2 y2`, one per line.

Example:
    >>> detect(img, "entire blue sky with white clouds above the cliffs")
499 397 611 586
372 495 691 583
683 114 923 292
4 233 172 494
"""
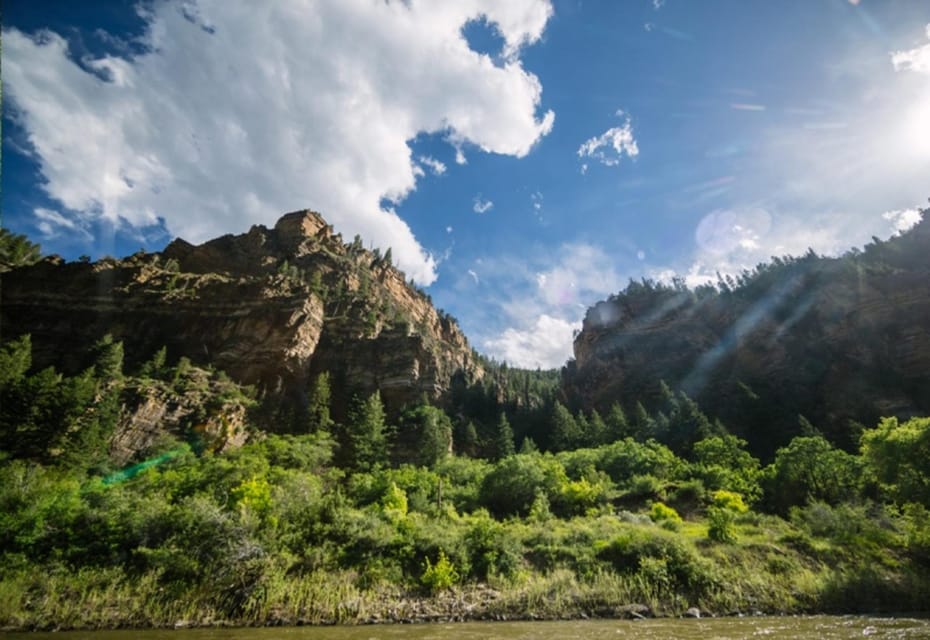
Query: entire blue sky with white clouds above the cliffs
0 0 930 368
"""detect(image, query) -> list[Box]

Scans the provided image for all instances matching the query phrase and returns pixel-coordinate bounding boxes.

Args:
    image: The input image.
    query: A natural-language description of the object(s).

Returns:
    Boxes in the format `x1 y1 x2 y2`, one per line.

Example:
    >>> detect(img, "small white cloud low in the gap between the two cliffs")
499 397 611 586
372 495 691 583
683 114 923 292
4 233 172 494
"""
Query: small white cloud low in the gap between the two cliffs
485 313 581 369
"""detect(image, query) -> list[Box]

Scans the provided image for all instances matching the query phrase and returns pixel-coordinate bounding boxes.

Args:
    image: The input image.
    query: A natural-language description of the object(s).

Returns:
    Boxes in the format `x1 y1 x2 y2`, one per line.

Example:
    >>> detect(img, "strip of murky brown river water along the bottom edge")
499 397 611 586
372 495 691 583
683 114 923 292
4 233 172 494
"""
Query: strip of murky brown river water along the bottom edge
7 616 930 640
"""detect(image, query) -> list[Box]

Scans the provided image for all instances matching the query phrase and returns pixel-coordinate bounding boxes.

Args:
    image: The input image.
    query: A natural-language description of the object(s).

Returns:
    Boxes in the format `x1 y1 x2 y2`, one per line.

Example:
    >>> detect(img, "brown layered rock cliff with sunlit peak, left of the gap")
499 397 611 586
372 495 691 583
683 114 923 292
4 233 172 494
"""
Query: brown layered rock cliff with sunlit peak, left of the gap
2 211 482 412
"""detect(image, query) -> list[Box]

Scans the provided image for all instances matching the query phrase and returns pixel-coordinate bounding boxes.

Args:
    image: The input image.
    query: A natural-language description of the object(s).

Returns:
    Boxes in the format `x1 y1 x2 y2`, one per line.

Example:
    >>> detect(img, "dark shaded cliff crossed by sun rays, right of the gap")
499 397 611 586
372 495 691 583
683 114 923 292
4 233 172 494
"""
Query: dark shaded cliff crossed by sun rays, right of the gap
563 212 930 454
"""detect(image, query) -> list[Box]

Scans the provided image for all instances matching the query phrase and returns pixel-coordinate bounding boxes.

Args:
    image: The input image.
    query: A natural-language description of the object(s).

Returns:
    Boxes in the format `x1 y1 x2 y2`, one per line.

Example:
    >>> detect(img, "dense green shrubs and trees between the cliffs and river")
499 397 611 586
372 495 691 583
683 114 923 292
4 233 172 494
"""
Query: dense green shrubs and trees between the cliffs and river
0 337 930 628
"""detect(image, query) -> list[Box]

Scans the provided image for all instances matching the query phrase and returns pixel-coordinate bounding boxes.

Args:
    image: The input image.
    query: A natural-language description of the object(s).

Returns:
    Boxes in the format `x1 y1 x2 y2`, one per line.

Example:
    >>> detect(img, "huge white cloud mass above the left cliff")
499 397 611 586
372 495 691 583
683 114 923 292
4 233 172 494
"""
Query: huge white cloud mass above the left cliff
3 0 554 284
